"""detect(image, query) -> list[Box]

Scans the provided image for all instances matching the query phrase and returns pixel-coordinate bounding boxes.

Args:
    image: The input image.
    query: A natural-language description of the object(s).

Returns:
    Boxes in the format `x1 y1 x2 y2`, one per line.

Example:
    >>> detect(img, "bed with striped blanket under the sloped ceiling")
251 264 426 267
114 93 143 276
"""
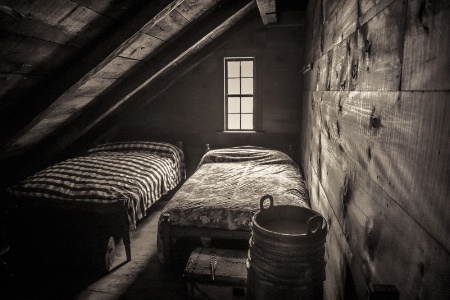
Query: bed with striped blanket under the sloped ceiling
7 141 186 270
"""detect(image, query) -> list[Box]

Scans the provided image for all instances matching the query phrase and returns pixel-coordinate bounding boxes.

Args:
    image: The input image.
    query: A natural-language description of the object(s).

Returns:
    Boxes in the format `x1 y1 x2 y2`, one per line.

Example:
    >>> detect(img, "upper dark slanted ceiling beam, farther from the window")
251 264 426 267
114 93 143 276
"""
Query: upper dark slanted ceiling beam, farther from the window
5 0 179 150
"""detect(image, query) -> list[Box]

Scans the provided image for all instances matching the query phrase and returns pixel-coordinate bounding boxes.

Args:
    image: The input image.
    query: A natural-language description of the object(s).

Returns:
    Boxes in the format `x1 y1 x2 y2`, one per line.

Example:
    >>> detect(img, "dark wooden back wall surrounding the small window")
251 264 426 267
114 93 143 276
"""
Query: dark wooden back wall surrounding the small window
103 10 304 174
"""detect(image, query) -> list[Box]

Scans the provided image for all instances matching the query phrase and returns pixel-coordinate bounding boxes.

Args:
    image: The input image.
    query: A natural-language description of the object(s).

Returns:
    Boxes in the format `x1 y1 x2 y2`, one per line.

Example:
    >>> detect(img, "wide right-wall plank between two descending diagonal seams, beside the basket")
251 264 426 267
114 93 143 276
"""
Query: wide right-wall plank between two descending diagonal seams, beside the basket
312 113 450 299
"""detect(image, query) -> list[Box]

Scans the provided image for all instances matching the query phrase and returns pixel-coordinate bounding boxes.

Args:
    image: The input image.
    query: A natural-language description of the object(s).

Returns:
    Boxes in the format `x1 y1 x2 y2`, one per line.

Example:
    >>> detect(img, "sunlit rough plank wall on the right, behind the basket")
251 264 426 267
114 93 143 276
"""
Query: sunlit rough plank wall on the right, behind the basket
300 0 450 299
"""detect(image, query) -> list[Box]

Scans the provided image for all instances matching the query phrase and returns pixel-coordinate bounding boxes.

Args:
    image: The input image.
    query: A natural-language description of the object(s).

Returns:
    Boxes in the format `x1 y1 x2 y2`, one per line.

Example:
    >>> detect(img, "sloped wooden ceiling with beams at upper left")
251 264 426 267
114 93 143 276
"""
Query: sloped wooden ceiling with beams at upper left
0 0 307 184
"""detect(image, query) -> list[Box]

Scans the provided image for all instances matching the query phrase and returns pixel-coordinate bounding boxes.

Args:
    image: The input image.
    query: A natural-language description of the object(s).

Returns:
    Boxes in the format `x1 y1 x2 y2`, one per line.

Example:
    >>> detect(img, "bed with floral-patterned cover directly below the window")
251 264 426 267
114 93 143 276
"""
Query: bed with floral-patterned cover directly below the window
157 146 310 266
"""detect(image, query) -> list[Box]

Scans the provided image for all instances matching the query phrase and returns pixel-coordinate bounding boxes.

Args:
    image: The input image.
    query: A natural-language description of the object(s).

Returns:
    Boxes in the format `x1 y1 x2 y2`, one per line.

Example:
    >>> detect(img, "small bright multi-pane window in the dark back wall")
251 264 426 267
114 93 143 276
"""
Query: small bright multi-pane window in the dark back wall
225 58 255 131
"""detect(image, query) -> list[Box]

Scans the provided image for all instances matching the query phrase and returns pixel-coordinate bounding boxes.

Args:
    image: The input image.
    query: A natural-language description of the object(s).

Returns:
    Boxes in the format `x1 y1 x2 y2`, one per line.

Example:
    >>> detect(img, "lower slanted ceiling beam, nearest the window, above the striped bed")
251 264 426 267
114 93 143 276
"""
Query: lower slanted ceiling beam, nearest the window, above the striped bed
0 0 256 183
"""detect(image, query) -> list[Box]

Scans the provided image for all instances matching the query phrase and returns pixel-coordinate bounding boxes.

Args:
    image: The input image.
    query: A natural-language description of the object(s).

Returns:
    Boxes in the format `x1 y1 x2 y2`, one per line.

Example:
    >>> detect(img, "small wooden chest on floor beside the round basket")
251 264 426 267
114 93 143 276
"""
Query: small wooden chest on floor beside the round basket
183 248 247 299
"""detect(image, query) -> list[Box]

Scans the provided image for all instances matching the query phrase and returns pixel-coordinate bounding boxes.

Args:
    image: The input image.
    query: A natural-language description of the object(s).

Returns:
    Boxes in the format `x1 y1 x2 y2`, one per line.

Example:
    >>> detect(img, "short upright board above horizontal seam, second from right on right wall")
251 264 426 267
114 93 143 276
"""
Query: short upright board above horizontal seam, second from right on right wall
353 0 406 91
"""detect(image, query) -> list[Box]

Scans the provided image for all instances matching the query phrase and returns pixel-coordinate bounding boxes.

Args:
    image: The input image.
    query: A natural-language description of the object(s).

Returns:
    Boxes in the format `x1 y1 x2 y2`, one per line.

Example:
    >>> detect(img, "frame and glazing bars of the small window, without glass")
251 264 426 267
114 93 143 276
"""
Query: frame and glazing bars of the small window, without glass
223 57 258 132
